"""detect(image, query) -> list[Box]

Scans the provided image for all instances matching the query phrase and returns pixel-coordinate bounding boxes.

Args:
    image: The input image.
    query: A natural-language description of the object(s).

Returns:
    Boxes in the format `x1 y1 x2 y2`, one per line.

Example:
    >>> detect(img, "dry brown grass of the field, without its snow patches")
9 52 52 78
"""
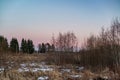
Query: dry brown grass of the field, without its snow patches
0 53 120 80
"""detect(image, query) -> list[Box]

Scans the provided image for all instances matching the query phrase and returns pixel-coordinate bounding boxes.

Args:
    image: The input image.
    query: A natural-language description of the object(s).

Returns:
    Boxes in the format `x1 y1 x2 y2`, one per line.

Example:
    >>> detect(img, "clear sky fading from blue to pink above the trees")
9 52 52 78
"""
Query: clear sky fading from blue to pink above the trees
0 0 120 46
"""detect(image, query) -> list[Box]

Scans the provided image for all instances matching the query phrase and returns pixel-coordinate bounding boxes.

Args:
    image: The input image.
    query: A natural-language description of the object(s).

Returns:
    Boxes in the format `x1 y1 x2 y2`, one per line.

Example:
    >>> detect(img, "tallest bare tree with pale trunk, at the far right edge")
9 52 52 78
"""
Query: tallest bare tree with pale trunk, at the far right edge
109 19 120 66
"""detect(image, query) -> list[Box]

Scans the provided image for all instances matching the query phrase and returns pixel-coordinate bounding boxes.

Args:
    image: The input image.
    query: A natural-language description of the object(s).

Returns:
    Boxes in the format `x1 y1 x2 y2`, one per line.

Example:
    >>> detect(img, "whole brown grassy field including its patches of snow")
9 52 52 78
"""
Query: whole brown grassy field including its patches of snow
0 53 120 80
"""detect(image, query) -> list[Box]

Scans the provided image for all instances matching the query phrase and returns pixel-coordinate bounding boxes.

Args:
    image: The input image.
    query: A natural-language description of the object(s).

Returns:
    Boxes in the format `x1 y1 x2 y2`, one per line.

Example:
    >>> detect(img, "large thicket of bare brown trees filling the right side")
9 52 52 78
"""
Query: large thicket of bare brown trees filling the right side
81 19 120 70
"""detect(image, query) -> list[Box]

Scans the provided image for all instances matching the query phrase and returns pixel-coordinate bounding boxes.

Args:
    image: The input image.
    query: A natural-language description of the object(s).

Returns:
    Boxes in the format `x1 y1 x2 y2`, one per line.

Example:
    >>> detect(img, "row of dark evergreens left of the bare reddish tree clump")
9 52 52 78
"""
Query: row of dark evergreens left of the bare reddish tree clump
0 36 55 54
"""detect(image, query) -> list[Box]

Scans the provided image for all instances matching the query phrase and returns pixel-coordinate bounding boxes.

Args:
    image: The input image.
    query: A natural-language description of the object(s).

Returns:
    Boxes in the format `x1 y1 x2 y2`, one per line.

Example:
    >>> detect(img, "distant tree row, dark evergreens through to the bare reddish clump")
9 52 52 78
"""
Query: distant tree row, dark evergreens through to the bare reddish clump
0 32 78 54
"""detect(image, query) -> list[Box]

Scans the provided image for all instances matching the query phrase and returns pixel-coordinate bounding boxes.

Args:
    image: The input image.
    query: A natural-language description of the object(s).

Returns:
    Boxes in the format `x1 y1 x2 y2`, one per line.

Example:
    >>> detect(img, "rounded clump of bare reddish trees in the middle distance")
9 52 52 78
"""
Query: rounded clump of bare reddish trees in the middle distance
56 32 78 52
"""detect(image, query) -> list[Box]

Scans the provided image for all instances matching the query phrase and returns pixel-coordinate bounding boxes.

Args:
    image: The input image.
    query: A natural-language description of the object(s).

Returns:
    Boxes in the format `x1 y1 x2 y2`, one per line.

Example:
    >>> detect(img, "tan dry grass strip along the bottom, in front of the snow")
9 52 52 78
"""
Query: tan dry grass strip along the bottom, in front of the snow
0 70 120 80
